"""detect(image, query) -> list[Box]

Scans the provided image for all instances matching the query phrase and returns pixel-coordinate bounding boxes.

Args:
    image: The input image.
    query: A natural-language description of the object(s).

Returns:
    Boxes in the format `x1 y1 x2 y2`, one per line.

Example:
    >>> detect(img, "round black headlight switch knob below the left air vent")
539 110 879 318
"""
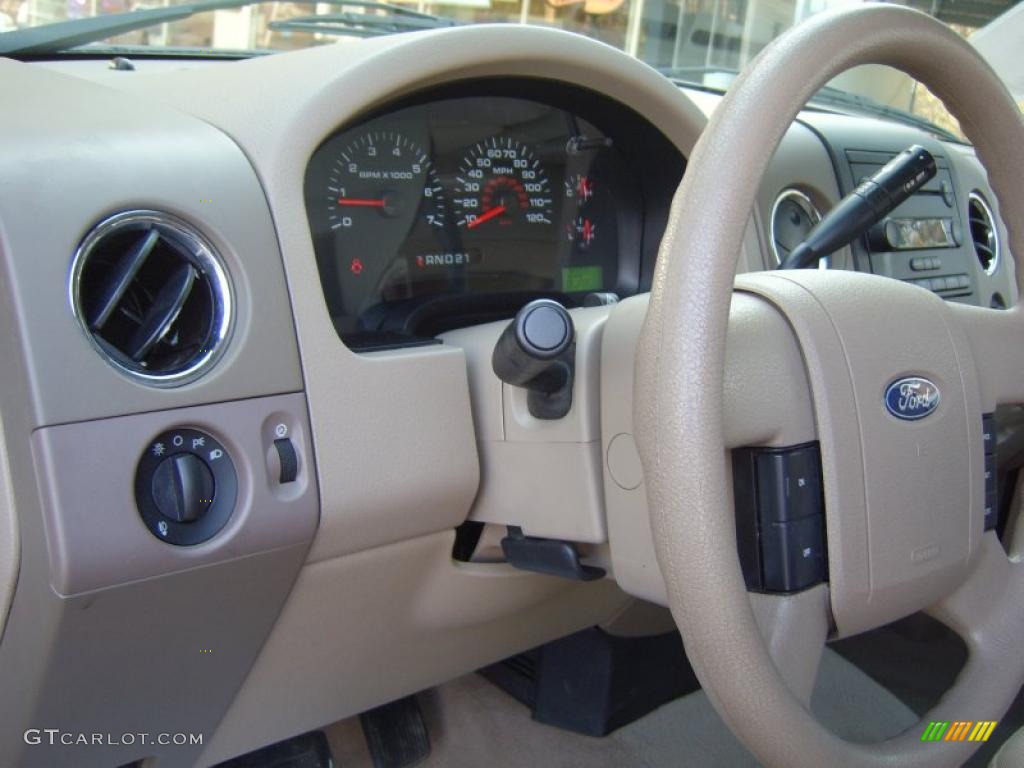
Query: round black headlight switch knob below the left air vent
135 427 238 546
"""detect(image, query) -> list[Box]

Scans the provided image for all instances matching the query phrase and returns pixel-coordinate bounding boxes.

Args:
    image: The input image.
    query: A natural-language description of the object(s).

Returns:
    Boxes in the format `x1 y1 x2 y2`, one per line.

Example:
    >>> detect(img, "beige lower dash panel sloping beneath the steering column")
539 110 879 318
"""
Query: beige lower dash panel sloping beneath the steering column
200 532 630 766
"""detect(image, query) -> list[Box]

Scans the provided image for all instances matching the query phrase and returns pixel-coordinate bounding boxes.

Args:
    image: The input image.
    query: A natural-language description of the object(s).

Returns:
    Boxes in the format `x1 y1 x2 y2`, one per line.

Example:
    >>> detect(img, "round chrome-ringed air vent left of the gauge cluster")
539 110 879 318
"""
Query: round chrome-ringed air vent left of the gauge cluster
71 211 231 386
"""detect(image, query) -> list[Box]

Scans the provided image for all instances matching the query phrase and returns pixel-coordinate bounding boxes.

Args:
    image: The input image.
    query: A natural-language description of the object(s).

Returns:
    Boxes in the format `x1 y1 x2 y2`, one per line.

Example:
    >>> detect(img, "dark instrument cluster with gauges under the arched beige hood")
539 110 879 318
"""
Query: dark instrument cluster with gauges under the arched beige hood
304 81 683 350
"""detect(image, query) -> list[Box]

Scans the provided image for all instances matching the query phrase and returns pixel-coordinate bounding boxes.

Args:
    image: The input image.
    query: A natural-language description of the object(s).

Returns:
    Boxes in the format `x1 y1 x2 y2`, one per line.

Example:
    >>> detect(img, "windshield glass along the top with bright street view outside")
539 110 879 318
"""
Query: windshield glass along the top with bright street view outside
0 0 1024 135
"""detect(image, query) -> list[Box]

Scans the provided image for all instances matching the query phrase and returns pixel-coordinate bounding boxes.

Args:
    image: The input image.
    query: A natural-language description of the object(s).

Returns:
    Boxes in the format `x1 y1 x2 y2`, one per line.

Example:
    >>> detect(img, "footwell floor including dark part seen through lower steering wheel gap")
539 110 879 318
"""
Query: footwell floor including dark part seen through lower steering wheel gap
326 615 1024 768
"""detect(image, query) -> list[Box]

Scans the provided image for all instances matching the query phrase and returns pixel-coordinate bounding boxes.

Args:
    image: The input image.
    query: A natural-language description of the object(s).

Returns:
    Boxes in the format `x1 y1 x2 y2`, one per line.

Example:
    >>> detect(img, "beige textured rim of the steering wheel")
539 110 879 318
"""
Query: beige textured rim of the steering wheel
634 5 1024 766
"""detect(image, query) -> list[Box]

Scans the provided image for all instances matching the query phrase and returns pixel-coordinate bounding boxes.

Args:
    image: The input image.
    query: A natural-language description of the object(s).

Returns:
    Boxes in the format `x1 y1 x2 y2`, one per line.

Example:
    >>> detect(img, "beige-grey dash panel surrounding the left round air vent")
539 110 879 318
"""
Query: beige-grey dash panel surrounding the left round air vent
0 57 302 439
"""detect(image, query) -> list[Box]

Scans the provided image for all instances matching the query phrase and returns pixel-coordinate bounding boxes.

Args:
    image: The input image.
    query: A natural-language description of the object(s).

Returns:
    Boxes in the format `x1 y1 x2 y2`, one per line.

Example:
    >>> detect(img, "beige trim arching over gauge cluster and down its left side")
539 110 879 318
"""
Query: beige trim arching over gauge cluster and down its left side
105 25 705 562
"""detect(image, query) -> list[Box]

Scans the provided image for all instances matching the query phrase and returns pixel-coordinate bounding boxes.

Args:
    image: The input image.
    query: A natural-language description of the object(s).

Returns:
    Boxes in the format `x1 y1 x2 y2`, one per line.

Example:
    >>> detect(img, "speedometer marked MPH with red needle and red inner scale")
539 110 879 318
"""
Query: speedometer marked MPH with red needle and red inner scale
454 136 554 229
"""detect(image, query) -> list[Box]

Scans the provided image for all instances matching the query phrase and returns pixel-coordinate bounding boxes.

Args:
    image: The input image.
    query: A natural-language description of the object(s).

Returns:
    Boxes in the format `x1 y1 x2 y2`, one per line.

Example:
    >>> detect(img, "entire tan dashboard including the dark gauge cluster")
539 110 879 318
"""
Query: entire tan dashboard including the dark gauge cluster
0 26 1017 768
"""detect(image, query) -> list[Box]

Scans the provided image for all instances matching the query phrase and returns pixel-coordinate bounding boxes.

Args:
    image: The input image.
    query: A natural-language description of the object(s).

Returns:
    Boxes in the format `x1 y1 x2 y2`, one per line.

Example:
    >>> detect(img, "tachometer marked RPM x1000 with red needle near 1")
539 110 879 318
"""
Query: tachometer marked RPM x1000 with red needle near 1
328 131 445 242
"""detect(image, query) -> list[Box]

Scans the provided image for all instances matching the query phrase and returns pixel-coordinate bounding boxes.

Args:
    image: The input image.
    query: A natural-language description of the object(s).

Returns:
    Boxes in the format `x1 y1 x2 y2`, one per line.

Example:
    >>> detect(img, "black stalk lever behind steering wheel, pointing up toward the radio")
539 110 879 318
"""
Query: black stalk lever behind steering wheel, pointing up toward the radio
778 144 935 269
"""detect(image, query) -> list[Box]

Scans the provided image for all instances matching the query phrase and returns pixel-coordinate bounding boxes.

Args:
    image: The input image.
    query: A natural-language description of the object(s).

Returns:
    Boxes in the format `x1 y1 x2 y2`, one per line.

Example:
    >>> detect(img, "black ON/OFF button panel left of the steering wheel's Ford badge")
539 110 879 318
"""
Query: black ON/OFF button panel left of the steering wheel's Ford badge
732 442 827 593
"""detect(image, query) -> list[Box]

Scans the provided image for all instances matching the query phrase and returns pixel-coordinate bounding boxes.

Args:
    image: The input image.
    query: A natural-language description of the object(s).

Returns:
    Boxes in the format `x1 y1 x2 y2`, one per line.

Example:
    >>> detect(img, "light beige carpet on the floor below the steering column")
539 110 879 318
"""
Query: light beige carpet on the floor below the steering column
327 651 918 768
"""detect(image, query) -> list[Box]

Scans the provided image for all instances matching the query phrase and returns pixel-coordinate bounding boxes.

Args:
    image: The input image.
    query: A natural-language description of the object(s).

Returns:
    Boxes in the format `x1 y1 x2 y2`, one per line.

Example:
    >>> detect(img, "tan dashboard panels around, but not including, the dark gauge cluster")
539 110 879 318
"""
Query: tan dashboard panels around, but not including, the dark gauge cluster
0 26 1017 768
